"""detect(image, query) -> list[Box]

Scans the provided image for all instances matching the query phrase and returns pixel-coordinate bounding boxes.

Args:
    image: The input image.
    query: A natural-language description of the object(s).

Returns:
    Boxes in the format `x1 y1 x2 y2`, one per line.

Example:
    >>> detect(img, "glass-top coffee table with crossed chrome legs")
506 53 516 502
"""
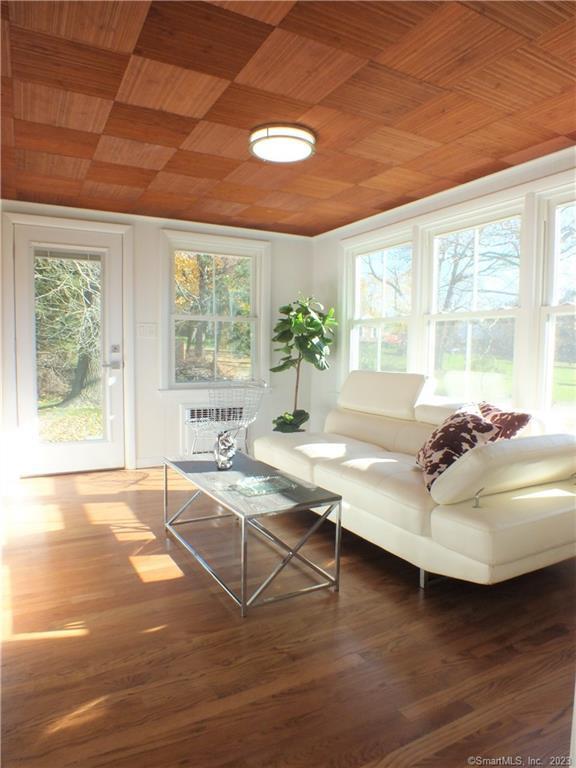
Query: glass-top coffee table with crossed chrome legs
164 454 342 617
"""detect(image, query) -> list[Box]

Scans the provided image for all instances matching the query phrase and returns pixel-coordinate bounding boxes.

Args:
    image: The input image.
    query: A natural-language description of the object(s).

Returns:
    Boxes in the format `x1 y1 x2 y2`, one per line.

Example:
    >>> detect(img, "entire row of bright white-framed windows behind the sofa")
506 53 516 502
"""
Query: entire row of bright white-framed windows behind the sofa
343 176 576 416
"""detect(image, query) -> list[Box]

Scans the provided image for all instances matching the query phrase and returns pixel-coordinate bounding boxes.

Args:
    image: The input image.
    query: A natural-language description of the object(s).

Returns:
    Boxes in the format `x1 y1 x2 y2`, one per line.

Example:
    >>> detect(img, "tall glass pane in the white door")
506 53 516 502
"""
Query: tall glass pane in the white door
34 249 105 443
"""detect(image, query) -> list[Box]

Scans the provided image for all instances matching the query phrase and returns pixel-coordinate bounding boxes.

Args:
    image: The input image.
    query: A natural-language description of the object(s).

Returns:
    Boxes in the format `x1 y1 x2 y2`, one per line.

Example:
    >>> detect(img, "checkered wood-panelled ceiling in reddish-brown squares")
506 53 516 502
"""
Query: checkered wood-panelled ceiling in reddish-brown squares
2 0 576 235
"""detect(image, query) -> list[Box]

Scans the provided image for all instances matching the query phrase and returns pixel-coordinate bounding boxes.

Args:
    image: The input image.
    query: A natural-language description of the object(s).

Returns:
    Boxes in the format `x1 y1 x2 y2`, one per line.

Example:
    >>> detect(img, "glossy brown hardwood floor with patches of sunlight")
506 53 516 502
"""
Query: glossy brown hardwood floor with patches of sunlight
3 469 575 768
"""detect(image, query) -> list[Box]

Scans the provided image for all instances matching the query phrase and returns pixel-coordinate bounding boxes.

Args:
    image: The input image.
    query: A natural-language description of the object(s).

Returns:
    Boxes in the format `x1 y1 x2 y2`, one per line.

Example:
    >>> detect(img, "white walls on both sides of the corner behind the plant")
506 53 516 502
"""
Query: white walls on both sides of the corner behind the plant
3 149 576 466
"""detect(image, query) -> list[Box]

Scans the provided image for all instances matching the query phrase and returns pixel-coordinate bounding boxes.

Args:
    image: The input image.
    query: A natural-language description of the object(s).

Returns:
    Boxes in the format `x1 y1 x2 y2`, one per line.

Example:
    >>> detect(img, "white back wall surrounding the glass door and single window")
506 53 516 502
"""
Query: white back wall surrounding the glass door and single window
2 202 312 466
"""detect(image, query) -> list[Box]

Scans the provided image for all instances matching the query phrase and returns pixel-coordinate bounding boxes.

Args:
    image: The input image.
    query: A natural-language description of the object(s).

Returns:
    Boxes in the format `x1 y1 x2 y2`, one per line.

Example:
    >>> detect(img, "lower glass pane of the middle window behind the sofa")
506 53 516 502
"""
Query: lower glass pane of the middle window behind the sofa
435 318 514 403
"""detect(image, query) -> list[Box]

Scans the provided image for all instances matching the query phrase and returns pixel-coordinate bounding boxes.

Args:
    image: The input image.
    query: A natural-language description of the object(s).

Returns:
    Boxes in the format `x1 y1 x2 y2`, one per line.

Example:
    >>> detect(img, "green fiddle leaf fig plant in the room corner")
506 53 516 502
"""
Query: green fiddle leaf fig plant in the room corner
270 297 338 432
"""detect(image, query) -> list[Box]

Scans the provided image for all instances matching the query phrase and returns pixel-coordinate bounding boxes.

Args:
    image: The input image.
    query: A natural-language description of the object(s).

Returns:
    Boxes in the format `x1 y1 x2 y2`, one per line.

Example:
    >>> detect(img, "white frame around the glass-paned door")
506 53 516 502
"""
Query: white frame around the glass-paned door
0 213 136 474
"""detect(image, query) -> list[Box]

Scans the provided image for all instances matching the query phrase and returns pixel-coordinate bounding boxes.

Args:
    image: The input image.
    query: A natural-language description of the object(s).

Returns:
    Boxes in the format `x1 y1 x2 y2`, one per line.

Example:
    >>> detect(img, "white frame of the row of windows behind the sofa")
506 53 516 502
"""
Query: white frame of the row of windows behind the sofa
340 170 576 418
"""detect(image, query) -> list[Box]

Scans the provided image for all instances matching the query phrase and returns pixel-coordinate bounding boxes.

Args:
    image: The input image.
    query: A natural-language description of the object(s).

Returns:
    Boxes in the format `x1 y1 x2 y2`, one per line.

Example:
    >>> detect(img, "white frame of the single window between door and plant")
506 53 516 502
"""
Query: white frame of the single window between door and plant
160 229 270 390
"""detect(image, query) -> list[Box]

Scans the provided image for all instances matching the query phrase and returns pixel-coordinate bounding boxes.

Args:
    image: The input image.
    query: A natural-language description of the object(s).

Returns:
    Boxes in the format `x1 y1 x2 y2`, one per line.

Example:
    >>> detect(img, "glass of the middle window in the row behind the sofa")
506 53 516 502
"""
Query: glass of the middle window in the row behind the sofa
431 216 521 402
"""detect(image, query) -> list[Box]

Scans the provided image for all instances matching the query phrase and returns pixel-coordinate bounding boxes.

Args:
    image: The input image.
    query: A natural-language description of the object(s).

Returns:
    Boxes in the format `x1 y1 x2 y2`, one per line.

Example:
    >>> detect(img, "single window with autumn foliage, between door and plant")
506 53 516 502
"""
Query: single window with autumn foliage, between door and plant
165 232 268 387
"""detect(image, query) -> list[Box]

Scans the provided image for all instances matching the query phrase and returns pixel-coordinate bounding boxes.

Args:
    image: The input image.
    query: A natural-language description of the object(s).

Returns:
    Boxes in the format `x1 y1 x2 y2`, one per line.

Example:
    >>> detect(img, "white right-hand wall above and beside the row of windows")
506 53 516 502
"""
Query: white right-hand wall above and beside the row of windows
310 148 576 430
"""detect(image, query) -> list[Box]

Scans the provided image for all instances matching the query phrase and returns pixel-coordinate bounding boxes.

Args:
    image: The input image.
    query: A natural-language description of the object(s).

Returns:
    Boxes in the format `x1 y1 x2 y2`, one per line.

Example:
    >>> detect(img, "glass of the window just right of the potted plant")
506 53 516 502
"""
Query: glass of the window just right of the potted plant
351 243 412 371
